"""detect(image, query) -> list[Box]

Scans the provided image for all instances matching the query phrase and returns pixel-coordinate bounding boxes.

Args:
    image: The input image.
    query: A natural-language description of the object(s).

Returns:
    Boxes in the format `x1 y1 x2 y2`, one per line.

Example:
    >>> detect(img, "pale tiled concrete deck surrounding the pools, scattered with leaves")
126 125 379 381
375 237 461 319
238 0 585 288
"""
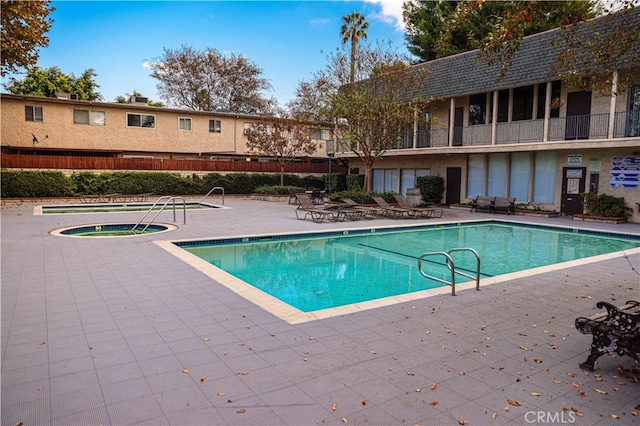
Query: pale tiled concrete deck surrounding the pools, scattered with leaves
1 196 640 425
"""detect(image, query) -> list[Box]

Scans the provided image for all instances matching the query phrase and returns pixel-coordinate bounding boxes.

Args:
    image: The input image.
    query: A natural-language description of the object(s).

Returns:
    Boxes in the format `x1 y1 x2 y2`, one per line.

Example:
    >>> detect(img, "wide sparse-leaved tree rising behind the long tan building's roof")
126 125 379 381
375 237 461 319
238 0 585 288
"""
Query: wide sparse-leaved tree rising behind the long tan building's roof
151 46 272 114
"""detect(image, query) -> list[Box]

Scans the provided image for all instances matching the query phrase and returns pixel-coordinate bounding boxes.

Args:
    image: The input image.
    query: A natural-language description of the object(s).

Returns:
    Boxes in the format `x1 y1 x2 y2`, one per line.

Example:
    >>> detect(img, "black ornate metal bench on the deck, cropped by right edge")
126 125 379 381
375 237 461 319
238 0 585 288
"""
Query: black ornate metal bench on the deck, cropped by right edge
575 301 640 371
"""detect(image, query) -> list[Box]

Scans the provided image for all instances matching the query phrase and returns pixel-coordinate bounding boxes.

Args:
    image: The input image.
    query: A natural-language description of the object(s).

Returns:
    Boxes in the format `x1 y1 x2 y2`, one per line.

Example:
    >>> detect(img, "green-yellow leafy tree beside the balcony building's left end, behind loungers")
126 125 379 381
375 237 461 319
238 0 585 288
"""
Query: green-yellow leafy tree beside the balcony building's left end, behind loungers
332 61 425 193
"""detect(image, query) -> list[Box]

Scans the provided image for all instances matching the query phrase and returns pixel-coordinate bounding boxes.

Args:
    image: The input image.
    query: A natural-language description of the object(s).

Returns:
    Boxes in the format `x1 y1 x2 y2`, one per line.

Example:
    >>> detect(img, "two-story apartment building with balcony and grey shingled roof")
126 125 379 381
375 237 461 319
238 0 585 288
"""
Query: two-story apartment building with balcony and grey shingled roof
339 9 640 222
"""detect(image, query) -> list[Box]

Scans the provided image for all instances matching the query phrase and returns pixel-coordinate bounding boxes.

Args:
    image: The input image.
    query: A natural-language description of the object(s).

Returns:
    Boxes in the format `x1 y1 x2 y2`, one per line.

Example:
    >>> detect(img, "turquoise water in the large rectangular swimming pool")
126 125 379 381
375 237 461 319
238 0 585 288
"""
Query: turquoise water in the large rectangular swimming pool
174 222 640 312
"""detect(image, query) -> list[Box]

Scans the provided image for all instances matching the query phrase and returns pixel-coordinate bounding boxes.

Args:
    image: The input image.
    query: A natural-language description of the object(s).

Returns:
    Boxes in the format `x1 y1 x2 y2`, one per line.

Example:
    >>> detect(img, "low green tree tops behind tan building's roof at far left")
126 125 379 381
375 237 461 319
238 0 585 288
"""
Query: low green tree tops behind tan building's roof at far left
4 67 102 101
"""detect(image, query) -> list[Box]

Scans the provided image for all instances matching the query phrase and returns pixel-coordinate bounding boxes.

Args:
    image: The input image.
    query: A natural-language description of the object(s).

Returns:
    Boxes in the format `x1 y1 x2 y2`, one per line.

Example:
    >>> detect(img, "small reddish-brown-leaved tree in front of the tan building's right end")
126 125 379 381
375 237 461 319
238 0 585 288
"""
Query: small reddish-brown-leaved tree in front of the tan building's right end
247 108 318 186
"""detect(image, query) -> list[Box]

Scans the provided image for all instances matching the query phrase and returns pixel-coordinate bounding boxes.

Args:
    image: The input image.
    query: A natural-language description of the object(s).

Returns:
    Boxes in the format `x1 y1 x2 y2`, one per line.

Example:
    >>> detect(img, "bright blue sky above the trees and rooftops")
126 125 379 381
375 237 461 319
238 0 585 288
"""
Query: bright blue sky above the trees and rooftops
13 0 408 104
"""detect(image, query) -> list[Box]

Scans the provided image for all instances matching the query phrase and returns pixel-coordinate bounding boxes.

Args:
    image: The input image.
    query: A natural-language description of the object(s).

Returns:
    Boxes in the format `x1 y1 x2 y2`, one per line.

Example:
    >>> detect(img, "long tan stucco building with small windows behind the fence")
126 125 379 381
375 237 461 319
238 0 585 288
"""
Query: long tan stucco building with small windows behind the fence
0 94 332 161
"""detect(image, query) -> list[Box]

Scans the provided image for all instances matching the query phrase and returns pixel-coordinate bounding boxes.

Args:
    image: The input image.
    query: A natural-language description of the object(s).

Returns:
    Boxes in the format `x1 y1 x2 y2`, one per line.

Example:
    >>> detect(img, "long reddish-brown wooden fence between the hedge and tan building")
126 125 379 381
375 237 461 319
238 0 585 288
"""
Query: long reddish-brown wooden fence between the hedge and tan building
0 154 347 174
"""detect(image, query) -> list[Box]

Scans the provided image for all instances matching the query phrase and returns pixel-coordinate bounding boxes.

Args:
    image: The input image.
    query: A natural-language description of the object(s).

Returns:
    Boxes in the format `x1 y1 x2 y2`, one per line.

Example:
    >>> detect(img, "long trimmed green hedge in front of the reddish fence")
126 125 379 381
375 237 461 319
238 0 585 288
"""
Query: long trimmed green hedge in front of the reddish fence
0 170 324 198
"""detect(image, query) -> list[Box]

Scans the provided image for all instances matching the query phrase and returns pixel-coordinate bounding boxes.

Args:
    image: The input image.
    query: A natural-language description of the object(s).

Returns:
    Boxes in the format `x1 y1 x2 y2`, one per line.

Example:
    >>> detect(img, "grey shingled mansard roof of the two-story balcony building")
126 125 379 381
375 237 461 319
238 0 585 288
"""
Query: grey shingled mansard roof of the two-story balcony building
407 7 640 103
